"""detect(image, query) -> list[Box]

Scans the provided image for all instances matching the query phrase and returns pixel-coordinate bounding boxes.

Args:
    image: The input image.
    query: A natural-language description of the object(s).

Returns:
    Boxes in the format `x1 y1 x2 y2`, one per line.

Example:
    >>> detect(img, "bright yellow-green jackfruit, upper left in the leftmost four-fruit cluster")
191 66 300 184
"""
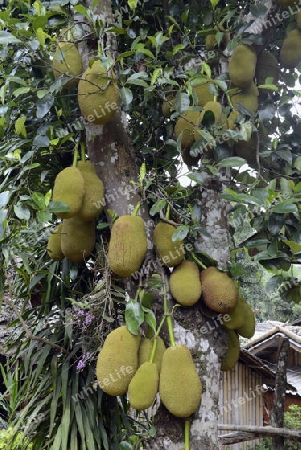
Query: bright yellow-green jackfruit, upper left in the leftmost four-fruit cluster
52 167 85 219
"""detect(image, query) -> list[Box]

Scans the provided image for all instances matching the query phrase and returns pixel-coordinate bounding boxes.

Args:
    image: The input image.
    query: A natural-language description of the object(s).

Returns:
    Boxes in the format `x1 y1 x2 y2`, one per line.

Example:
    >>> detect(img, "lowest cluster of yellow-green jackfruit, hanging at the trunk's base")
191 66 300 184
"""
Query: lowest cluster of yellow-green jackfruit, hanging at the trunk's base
96 325 202 418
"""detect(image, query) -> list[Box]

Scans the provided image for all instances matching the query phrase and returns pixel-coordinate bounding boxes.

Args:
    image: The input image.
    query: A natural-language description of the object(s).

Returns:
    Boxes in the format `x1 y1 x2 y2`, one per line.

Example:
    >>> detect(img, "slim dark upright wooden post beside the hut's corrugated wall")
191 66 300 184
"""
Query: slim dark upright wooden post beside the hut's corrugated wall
271 338 289 450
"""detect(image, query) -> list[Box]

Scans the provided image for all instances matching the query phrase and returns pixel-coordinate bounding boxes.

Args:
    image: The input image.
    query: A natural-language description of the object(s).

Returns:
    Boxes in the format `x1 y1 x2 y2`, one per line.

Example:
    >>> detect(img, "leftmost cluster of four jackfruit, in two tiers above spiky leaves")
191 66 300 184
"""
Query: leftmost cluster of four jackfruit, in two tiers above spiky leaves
47 161 104 262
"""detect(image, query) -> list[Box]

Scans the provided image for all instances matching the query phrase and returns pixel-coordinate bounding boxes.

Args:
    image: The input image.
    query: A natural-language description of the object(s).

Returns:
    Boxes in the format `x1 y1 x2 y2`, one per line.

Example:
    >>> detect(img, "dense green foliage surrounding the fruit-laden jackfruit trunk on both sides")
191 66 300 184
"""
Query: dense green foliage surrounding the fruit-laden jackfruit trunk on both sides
0 0 301 450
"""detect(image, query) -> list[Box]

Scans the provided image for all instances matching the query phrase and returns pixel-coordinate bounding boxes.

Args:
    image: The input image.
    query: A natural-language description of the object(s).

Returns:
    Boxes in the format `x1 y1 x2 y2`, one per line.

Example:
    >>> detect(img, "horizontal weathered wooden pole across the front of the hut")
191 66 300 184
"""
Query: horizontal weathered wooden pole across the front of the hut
218 425 301 442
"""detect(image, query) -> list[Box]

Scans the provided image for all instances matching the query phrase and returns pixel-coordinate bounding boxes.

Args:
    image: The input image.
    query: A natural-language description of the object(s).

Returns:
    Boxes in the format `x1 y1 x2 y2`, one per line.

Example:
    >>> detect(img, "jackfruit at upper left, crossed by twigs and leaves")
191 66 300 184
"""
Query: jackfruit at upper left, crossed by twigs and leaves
52 42 83 88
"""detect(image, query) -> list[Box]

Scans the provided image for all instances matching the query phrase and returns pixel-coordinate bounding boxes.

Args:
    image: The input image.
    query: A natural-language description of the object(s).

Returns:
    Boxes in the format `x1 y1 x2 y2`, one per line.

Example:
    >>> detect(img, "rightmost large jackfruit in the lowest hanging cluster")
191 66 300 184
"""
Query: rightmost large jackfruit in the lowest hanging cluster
159 345 202 418
